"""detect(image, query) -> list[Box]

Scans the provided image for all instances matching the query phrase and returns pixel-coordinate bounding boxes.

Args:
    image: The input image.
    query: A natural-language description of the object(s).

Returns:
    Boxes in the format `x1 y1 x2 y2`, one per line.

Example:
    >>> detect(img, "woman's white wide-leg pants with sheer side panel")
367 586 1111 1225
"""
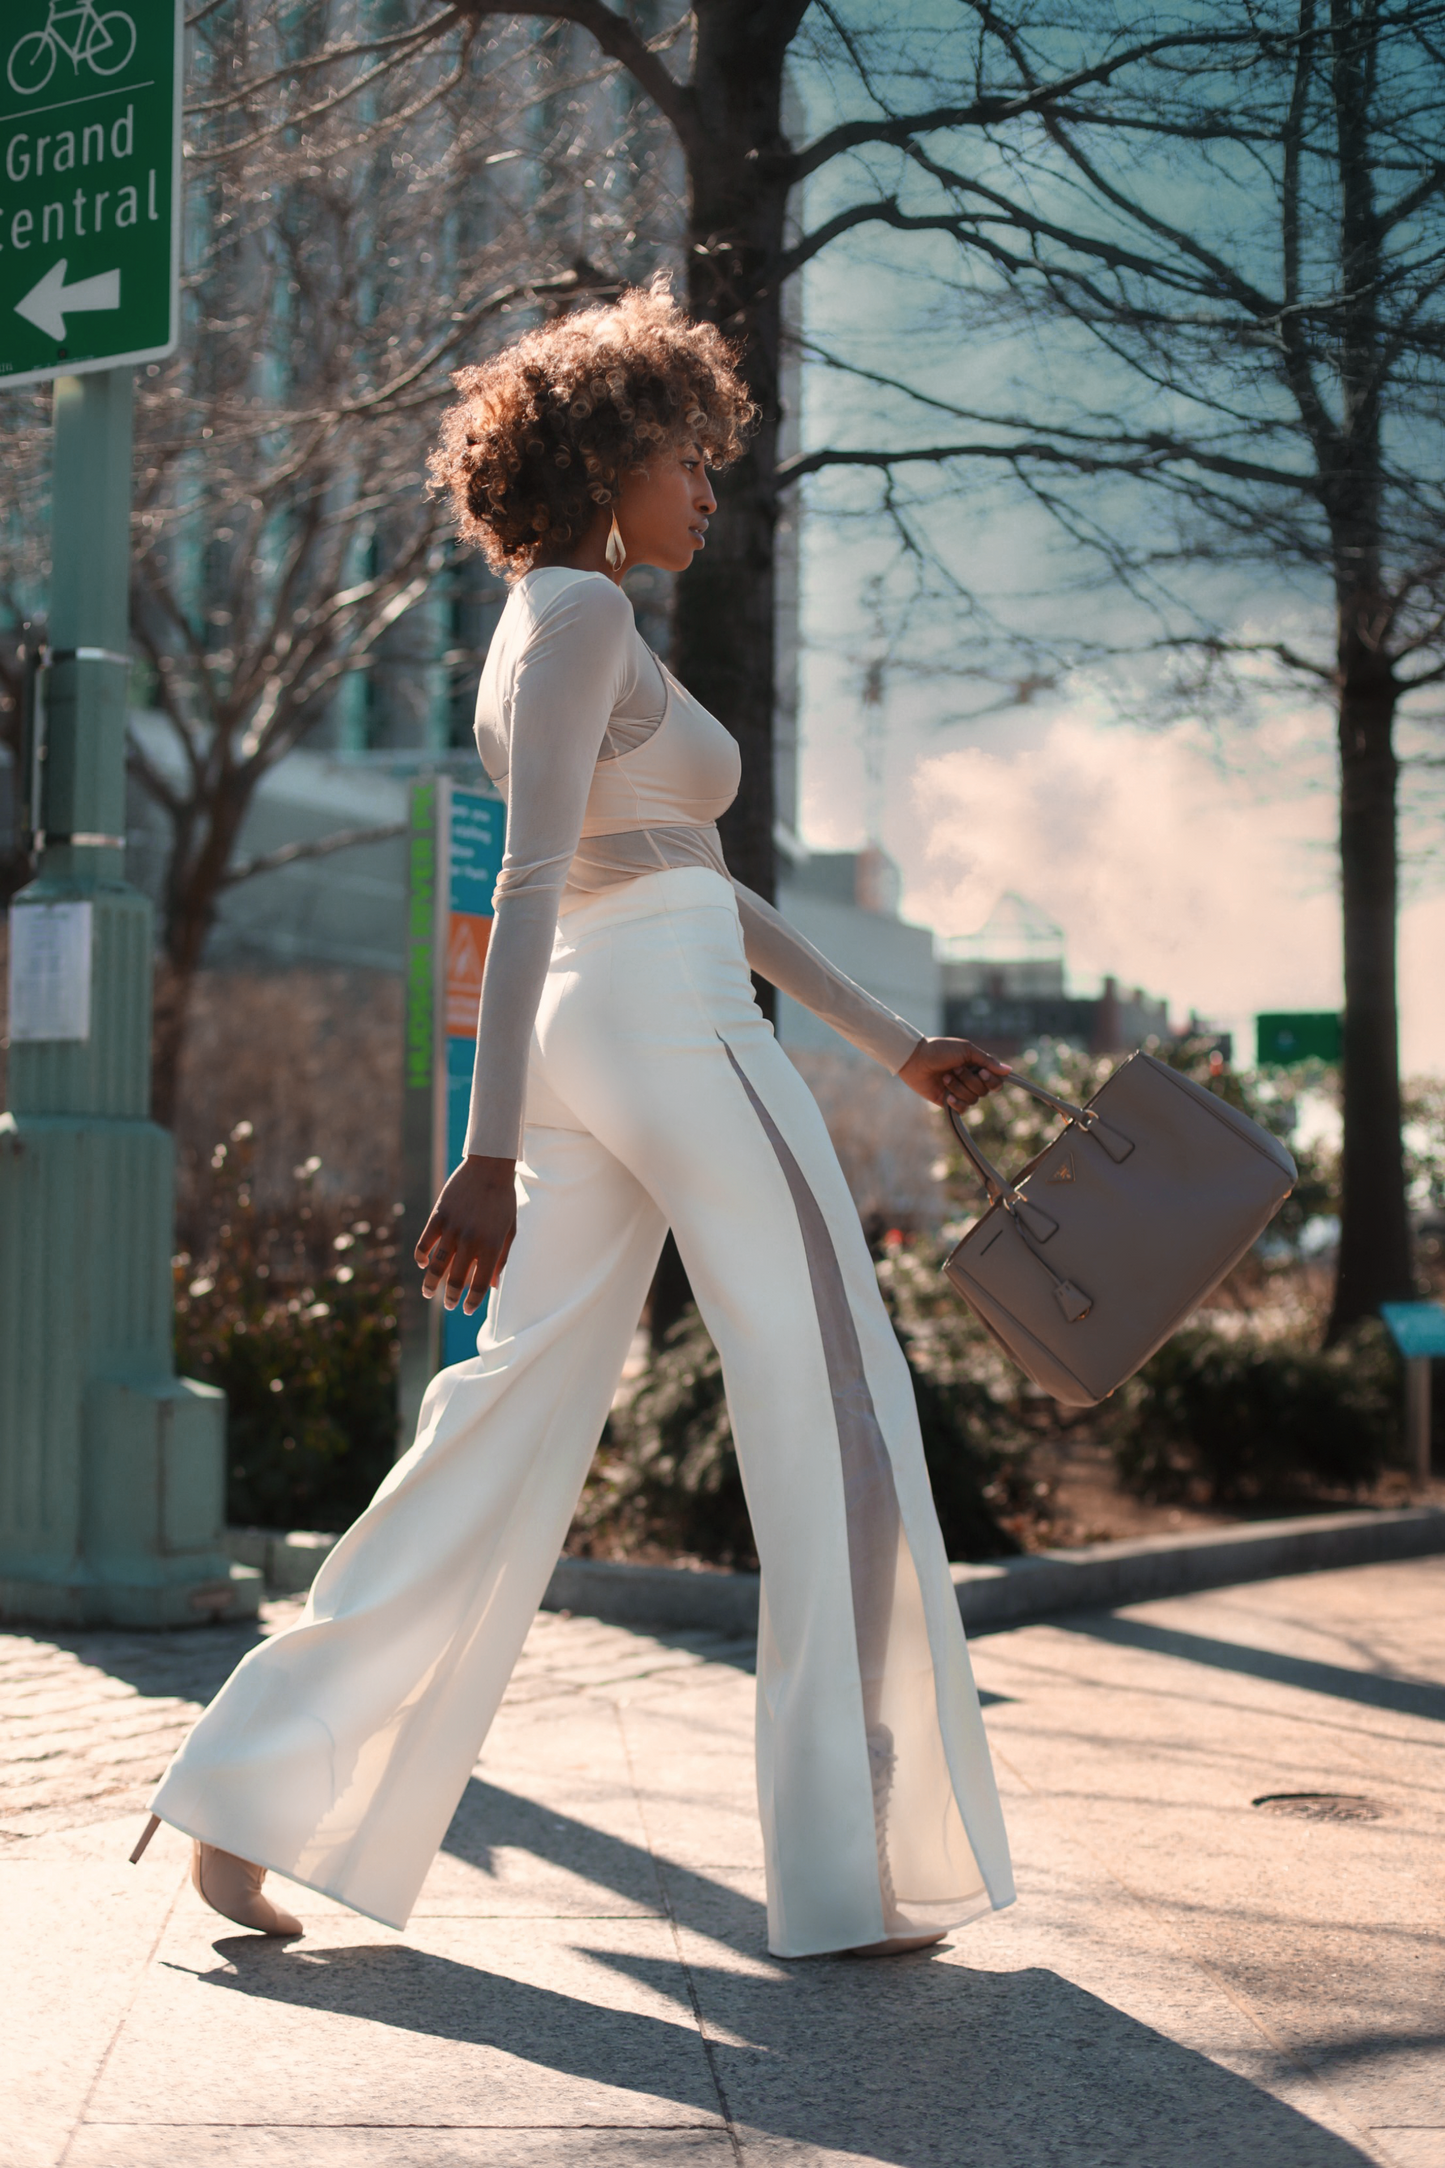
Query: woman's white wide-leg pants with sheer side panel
152 867 1014 1958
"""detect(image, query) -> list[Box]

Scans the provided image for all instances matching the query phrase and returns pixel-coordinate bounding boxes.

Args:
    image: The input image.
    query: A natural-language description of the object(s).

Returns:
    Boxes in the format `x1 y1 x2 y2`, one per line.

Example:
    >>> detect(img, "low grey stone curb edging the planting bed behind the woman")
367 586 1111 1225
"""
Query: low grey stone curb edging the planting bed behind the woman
225 1507 1445 1639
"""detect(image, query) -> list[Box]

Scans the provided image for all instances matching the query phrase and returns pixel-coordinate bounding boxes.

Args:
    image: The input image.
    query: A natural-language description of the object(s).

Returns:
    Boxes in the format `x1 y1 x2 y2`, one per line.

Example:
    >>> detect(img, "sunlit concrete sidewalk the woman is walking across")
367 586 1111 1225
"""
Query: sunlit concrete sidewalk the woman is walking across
0 1559 1445 2168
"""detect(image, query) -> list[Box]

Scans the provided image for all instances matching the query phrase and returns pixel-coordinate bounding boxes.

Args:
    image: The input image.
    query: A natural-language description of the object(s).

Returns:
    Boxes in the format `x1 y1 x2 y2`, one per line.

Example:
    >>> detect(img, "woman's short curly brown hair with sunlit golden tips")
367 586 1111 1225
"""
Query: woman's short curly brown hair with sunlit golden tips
427 280 758 579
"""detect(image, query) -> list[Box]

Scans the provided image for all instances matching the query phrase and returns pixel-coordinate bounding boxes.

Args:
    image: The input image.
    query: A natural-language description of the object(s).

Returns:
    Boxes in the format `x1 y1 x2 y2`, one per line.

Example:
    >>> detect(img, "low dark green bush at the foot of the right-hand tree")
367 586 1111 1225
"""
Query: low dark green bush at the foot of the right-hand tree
1107 1320 1400 1507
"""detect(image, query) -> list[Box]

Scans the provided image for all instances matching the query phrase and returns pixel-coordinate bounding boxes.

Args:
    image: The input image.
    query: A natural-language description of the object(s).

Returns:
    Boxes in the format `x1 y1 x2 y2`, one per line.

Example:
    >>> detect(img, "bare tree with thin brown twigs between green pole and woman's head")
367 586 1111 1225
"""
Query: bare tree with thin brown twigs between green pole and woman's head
0 0 672 1123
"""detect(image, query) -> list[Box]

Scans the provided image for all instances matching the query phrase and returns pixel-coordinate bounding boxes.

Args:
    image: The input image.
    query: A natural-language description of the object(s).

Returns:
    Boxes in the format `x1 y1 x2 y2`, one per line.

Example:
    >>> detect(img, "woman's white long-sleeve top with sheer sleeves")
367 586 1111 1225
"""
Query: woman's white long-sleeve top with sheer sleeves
466 566 921 1160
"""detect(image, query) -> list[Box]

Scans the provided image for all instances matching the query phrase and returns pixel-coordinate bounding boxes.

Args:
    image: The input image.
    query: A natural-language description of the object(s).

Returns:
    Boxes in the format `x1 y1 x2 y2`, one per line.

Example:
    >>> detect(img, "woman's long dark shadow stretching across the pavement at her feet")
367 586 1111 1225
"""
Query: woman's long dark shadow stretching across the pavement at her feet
184 1780 1367 2168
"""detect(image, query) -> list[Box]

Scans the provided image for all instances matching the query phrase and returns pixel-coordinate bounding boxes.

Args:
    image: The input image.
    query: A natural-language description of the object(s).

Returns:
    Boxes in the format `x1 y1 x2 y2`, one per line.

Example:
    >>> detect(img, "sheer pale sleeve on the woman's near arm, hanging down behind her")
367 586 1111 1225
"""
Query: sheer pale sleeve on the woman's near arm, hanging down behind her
466 579 635 1160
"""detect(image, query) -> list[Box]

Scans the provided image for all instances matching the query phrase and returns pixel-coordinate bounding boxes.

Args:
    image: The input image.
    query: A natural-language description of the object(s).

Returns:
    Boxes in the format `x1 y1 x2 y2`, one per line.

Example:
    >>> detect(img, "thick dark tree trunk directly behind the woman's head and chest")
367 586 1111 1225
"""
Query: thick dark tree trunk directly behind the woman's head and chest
674 0 802 900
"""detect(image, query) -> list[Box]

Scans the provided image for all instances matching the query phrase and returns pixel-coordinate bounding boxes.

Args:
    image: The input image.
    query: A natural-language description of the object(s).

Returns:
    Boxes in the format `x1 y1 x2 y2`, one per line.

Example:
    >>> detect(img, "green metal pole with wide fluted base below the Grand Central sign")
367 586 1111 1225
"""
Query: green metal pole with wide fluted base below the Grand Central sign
0 369 260 1626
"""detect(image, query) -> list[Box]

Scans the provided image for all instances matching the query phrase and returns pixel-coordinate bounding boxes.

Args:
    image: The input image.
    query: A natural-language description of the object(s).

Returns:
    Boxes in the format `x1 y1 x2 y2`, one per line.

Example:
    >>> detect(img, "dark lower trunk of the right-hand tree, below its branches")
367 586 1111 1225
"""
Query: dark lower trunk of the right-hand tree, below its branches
1326 611 1415 1344
